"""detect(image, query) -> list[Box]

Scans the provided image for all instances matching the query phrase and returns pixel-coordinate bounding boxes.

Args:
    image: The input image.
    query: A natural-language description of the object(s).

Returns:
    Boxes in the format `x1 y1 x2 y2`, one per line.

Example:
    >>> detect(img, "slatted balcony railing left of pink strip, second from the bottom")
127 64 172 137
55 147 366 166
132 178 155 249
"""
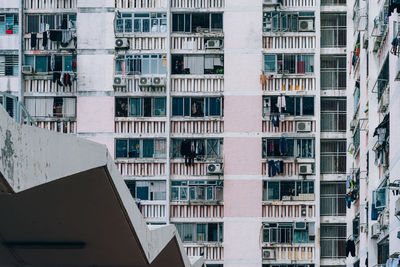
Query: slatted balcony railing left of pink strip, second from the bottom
171 204 224 219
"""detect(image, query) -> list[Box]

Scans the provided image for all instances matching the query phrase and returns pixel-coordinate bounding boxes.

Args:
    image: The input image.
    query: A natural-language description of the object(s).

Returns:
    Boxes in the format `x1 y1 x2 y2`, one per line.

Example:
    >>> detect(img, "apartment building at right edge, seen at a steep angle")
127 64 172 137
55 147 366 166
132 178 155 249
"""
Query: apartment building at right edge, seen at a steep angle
346 1 400 266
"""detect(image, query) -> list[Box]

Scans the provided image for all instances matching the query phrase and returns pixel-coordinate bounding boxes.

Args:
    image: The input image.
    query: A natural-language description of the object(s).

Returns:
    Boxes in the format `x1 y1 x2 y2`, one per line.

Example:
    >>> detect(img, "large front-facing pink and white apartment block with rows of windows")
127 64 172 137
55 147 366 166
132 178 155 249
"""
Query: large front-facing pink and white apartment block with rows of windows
0 0 352 267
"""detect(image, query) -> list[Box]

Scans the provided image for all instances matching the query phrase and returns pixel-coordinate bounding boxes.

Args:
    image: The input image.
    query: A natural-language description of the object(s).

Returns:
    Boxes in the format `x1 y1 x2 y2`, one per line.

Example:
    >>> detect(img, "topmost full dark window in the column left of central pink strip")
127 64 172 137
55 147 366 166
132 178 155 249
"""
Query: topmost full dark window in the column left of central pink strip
172 12 223 33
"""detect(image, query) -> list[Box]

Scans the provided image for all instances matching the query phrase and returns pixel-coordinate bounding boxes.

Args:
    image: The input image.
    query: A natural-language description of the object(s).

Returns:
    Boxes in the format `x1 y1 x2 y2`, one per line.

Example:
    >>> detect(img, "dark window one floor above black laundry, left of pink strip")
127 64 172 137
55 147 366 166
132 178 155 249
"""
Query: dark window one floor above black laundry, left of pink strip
172 97 222 117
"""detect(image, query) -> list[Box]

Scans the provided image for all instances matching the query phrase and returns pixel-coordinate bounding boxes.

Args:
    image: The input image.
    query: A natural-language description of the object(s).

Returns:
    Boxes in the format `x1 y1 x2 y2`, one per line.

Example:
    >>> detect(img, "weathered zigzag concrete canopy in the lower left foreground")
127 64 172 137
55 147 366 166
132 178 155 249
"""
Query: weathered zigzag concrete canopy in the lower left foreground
0 108 203 266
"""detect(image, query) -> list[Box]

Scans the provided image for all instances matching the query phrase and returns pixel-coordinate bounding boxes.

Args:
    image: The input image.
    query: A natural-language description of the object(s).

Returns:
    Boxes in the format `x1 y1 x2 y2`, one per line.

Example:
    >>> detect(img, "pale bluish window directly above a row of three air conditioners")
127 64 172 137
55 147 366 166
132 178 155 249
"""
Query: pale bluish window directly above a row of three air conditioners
115 55 167 75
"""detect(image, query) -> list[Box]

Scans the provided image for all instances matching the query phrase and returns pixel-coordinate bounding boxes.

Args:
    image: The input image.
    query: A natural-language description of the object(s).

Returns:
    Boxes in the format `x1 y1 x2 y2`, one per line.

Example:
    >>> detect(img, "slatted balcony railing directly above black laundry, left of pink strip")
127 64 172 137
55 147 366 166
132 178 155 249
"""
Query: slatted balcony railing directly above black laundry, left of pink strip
171 118 224 134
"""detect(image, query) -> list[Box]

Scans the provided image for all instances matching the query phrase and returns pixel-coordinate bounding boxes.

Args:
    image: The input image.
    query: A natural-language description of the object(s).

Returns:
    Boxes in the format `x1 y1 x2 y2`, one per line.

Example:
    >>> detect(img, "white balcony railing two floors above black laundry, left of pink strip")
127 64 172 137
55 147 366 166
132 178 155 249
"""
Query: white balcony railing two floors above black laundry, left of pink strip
171 74 224 95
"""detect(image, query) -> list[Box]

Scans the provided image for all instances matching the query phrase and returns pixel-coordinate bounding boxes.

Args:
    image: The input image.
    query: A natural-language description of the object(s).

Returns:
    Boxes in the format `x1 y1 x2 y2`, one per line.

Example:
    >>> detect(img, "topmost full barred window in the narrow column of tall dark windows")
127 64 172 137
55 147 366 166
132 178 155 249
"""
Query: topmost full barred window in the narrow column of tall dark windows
321 13 346 47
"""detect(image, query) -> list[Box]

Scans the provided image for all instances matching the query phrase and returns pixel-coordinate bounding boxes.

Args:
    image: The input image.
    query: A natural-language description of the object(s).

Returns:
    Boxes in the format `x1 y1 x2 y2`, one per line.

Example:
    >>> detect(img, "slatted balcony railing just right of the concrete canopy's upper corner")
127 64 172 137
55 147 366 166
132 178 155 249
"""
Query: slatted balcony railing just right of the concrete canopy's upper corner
115 159 166 177
